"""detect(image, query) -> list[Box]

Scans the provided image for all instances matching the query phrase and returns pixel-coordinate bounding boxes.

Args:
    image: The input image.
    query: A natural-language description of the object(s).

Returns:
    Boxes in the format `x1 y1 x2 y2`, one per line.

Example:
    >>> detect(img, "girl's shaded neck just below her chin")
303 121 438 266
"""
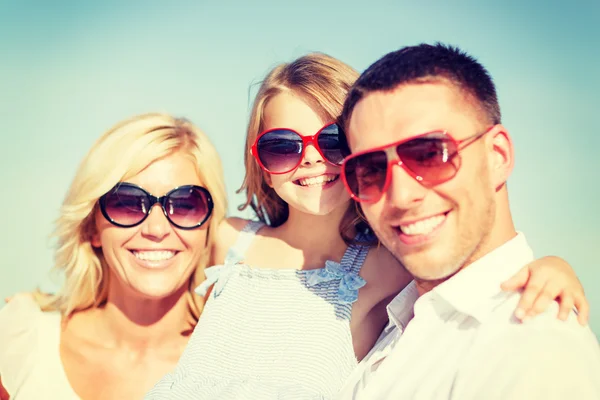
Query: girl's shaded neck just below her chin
278 203 348 254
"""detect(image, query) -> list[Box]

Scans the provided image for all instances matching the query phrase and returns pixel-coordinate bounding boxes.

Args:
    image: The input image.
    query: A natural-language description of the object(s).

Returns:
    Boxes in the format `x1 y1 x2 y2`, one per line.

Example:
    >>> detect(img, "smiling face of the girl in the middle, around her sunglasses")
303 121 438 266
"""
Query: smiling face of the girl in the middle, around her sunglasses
263 92 350 215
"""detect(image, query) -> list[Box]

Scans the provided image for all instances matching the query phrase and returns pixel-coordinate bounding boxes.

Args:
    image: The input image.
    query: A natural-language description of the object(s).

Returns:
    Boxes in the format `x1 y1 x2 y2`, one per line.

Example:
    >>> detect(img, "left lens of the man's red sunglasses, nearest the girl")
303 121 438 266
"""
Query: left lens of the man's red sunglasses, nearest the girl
343 151 387 201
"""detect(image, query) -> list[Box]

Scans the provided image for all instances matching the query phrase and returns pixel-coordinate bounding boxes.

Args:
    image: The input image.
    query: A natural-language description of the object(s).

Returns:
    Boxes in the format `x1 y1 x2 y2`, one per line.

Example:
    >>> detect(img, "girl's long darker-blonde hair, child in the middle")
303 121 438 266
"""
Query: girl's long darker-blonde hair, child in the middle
238 53 367 243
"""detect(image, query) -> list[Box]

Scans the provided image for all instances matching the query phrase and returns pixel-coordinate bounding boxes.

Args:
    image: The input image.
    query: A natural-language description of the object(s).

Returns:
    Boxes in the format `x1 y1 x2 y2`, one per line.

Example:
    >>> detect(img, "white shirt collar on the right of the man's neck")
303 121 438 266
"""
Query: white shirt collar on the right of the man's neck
432 233 534 322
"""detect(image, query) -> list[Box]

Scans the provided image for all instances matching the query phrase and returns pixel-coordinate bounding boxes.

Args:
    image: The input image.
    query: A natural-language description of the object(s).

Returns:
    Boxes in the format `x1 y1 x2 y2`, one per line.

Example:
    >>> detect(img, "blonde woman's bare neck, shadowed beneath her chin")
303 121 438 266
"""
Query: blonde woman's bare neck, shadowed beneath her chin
92 281 193 349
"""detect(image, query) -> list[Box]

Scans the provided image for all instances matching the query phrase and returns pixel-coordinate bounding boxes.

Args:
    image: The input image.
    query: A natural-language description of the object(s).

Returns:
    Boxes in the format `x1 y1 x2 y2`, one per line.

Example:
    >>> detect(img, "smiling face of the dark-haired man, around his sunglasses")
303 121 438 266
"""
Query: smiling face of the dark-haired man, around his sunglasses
348 80 496 281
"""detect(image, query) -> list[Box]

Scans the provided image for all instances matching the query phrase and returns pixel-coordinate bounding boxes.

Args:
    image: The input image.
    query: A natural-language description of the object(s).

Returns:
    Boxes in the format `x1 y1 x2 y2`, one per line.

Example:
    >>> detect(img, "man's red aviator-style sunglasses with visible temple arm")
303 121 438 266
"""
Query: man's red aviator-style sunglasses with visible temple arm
342 126 493 203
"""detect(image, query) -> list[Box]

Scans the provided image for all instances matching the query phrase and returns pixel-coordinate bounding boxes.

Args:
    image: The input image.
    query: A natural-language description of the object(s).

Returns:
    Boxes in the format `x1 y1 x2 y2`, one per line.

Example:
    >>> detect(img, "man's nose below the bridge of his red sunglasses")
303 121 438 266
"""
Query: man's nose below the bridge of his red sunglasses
385 163 428 210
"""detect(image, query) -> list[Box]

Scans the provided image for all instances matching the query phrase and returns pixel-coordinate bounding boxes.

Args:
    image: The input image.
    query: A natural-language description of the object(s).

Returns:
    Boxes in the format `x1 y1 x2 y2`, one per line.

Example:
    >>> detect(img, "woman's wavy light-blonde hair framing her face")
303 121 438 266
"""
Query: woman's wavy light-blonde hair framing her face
36 113 227 324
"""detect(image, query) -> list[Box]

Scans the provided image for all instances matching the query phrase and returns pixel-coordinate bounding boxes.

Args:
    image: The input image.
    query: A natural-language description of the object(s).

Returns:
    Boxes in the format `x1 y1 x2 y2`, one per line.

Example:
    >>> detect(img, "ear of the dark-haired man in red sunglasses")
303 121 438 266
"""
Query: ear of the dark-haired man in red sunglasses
489 124 514 189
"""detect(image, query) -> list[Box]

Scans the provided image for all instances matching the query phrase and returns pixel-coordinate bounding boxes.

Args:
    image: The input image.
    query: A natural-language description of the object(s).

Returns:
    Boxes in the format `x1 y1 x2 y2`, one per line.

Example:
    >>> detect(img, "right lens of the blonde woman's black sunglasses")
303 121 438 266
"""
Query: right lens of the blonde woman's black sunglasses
165 186 212 228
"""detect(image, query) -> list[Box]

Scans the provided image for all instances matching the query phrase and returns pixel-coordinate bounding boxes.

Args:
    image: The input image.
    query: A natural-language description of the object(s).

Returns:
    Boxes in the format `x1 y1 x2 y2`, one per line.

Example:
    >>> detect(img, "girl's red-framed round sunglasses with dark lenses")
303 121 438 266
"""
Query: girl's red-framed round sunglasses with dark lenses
250 123 344 174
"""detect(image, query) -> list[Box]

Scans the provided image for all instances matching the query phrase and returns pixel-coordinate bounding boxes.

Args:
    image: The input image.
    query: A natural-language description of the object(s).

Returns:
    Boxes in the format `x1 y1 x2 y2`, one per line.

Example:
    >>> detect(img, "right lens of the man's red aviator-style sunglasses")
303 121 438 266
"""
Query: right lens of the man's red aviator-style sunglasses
396 133 458 183
